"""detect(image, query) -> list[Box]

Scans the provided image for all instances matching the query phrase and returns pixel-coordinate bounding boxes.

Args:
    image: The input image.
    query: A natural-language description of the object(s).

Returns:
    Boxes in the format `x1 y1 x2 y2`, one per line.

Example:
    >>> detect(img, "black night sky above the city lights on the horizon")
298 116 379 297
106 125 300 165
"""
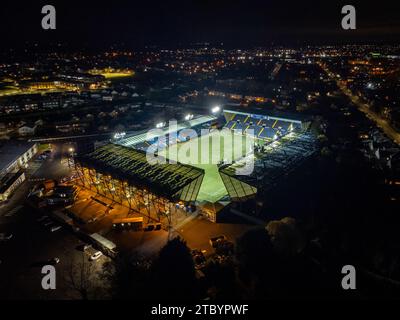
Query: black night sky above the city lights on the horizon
0 0 400 49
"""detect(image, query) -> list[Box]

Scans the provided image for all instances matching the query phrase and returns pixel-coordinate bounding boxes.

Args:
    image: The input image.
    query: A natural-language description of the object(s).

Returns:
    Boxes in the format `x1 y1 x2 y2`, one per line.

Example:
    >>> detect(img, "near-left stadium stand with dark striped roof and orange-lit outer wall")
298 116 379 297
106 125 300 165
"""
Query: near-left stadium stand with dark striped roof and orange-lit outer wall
75 144 204 213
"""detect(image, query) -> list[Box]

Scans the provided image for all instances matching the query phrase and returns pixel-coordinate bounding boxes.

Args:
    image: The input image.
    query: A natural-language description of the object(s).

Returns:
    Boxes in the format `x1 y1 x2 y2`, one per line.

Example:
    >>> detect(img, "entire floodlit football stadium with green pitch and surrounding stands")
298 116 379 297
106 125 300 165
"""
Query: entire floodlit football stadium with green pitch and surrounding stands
76 108 315 221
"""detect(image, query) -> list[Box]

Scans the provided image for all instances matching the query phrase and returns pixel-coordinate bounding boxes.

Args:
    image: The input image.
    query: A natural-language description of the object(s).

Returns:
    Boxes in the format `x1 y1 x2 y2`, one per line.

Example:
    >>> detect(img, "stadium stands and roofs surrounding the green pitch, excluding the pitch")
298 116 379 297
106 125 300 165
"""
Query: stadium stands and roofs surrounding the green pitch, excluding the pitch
75 107 316 221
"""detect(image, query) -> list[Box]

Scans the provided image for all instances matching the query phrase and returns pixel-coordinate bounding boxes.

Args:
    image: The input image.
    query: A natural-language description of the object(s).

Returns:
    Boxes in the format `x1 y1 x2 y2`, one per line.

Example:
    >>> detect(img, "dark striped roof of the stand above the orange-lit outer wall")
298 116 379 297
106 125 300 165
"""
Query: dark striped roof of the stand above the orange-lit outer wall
76 143 204 199
